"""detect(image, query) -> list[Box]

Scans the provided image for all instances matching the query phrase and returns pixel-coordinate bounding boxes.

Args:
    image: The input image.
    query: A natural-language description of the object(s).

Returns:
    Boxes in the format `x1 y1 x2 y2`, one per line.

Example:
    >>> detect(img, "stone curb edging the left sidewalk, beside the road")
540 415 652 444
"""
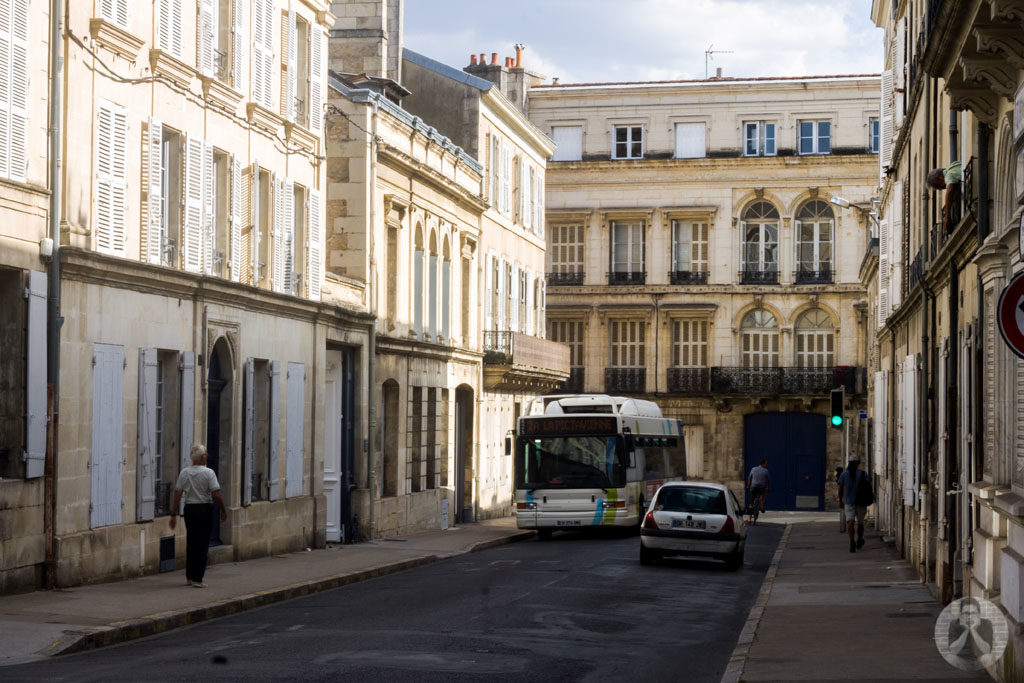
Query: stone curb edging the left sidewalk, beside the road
39 531 535 656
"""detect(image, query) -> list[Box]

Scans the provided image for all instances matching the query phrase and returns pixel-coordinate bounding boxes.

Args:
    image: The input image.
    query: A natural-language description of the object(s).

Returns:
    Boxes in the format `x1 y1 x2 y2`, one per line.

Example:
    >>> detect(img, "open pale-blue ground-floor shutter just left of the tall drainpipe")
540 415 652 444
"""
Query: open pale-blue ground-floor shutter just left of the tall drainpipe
25 270 46 478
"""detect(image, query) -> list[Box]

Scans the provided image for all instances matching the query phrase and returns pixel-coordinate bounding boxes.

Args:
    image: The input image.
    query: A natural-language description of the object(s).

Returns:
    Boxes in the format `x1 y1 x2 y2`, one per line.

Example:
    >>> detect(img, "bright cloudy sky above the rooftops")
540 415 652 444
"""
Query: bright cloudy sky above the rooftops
404 0 883 83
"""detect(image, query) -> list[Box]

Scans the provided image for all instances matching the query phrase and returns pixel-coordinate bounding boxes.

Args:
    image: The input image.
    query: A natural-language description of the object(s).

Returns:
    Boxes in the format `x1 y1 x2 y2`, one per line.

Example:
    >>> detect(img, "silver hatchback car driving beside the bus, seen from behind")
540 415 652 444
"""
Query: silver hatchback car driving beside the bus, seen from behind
640 481 746 570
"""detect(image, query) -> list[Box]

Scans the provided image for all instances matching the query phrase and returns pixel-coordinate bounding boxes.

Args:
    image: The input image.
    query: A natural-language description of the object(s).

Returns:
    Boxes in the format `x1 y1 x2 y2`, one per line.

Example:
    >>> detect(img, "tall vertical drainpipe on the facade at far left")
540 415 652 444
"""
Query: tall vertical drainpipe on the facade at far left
43 0 65 589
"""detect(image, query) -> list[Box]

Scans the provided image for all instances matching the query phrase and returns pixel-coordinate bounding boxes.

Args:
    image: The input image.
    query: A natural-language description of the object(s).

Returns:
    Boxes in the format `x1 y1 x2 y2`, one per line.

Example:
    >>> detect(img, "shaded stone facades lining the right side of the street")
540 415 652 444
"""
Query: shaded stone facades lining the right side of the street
862 0 1024 680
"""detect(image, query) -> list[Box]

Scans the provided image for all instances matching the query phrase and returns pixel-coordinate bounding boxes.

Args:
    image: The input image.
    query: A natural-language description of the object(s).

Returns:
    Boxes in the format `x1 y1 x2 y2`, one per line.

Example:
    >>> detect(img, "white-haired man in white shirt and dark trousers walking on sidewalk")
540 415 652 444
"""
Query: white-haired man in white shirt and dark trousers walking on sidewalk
171 443 227 588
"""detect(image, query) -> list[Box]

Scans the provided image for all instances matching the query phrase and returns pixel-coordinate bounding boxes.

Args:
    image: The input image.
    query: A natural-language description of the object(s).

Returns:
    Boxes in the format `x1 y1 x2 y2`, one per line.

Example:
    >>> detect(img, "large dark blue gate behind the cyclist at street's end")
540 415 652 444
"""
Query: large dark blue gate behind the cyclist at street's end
743 413 825 510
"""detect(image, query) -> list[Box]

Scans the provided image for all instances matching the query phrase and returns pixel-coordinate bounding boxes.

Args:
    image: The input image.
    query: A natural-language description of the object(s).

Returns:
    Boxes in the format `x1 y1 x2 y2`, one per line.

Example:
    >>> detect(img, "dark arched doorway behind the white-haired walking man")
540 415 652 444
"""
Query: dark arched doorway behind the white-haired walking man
206 337 233 546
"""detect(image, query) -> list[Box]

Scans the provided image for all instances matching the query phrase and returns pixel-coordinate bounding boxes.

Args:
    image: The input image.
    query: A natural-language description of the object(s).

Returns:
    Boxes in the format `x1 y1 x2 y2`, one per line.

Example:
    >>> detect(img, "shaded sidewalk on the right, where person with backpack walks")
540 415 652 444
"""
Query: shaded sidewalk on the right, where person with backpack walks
722 520 991 683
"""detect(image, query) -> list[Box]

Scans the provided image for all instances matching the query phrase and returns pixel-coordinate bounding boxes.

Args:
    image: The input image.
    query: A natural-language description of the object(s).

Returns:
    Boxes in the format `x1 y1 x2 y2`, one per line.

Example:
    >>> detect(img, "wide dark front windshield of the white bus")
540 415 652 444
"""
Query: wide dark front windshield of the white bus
515 435 627 488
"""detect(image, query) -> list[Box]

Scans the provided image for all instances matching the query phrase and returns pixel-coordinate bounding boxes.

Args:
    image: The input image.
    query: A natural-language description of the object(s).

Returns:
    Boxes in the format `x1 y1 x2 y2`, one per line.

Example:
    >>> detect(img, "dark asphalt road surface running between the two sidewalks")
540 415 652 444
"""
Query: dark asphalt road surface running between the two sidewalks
2 520 782 683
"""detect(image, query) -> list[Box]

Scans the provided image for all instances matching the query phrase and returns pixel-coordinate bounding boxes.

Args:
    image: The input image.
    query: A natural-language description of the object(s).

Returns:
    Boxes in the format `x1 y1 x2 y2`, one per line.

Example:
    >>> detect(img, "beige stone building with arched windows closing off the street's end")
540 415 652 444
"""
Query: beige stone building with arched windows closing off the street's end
528 76 879 509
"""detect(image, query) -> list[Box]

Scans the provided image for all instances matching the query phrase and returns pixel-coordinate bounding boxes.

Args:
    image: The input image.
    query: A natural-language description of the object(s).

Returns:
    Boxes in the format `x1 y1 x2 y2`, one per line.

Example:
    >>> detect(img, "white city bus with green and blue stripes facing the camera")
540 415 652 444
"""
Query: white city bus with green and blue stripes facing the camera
506 394 686 539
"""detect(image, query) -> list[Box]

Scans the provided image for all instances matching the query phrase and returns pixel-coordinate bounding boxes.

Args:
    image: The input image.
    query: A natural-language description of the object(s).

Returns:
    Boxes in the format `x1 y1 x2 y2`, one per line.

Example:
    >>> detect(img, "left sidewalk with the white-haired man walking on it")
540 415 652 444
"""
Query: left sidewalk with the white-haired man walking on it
0 517 534 663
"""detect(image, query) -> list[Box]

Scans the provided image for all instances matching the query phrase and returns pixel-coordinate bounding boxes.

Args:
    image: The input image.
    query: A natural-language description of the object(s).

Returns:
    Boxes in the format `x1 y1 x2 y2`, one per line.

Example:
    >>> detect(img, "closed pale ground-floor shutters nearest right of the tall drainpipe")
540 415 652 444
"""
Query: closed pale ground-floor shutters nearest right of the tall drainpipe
89 344 125 528
